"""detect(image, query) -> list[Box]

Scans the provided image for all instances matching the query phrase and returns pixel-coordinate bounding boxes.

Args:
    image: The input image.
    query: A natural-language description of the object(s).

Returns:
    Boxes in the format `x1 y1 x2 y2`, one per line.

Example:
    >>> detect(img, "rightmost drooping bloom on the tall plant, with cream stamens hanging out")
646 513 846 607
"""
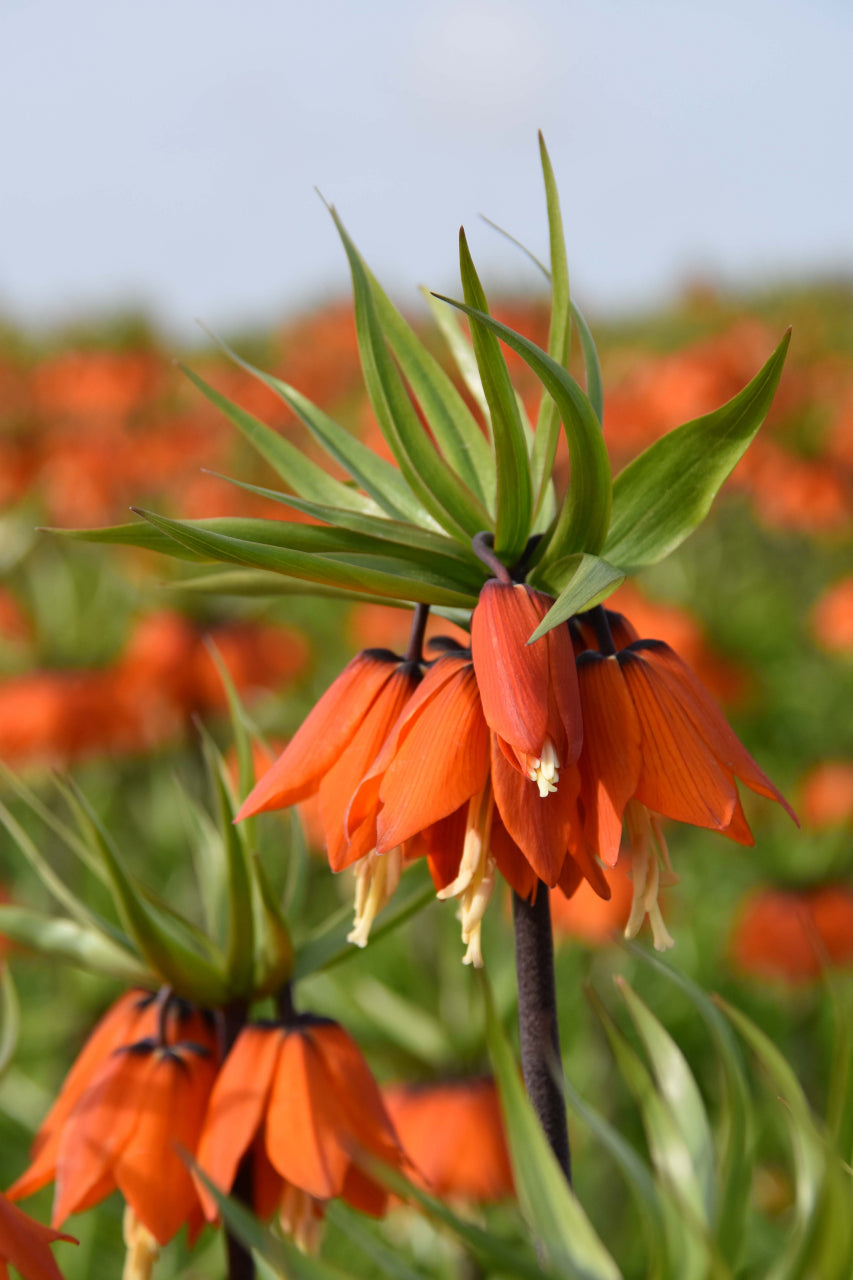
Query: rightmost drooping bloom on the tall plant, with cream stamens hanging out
568 613 797 948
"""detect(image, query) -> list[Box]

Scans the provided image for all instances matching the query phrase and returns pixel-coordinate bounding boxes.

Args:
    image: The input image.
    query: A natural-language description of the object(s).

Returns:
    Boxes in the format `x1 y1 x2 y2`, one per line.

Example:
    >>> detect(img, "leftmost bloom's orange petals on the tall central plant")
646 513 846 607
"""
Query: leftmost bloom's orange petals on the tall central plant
237 649 421 870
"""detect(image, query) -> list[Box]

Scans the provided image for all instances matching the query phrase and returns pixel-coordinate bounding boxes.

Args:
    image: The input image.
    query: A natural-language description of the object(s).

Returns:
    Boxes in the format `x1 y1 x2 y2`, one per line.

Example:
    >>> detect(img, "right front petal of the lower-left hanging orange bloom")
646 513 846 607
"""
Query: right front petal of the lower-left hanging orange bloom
113 1047 216 1244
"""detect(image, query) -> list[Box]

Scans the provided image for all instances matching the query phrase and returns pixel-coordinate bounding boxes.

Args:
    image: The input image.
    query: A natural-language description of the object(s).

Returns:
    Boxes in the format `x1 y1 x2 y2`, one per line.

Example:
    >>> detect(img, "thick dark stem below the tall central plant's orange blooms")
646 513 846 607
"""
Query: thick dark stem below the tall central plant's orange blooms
512 882 571 1183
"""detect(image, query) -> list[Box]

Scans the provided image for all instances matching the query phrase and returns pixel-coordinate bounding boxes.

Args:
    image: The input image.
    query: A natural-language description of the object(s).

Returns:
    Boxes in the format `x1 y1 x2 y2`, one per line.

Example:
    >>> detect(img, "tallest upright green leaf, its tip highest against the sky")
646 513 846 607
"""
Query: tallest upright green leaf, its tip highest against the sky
532 133 571 515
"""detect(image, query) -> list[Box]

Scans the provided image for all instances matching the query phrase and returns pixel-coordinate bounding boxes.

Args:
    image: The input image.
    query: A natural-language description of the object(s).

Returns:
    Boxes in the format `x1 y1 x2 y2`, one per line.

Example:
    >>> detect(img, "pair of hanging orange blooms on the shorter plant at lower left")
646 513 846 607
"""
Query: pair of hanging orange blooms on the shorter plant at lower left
8 989 403 1274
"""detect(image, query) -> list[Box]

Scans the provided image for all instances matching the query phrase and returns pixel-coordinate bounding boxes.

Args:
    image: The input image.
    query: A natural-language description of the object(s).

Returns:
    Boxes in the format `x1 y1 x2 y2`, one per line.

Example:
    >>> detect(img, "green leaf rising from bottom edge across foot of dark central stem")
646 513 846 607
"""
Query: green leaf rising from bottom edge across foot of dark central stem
483 977 620 1280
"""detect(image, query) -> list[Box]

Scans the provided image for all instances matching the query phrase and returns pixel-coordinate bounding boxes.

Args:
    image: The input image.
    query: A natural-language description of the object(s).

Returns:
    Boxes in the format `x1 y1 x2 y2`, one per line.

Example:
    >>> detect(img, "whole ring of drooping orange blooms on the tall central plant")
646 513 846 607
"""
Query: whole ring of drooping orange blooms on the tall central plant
238 575 793 965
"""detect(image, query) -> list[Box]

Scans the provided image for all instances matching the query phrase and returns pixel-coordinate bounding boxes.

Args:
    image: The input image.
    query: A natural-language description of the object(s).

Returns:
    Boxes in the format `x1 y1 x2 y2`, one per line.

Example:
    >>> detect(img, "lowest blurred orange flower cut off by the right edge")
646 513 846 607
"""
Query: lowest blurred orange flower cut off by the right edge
731 884 853 983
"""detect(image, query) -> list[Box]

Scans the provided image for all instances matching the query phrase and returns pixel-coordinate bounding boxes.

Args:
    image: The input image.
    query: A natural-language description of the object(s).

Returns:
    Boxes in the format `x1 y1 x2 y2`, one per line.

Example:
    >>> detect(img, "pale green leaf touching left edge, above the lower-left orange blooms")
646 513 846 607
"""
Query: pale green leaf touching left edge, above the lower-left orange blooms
0 902 151 987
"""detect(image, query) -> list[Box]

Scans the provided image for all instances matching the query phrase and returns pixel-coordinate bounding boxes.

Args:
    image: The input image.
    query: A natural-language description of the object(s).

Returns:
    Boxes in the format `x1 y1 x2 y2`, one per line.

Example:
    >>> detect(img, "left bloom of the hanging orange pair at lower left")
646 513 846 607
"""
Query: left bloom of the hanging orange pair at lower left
9 993 216 1244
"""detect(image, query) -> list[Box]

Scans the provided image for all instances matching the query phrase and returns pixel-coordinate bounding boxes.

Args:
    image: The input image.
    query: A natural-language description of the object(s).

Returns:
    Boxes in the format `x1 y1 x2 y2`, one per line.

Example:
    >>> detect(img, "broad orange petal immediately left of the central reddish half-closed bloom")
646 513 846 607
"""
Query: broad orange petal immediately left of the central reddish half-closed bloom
377 663 489 852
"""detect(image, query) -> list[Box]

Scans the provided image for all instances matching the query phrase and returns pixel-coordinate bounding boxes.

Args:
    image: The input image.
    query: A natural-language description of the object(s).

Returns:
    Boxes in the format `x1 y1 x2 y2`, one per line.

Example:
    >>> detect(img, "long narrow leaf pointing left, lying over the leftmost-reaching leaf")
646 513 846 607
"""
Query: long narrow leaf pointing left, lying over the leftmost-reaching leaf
131 509 476 608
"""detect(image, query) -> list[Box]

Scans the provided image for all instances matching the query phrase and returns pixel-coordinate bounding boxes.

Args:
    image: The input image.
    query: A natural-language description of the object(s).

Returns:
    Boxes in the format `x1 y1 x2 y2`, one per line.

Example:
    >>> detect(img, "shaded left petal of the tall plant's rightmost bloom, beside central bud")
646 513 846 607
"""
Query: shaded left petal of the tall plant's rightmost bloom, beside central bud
578 650 642 867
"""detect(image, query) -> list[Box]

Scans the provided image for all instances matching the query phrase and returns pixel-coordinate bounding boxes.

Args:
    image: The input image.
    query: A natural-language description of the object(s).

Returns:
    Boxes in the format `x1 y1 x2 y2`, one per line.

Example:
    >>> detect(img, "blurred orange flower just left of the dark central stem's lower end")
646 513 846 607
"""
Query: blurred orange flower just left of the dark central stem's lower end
383 1079 514 1204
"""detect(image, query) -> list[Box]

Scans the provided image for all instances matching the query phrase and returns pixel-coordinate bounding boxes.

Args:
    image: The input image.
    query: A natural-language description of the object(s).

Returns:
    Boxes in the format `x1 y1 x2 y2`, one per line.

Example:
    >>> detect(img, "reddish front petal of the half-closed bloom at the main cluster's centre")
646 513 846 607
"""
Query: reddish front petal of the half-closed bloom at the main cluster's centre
471 579 552 756
